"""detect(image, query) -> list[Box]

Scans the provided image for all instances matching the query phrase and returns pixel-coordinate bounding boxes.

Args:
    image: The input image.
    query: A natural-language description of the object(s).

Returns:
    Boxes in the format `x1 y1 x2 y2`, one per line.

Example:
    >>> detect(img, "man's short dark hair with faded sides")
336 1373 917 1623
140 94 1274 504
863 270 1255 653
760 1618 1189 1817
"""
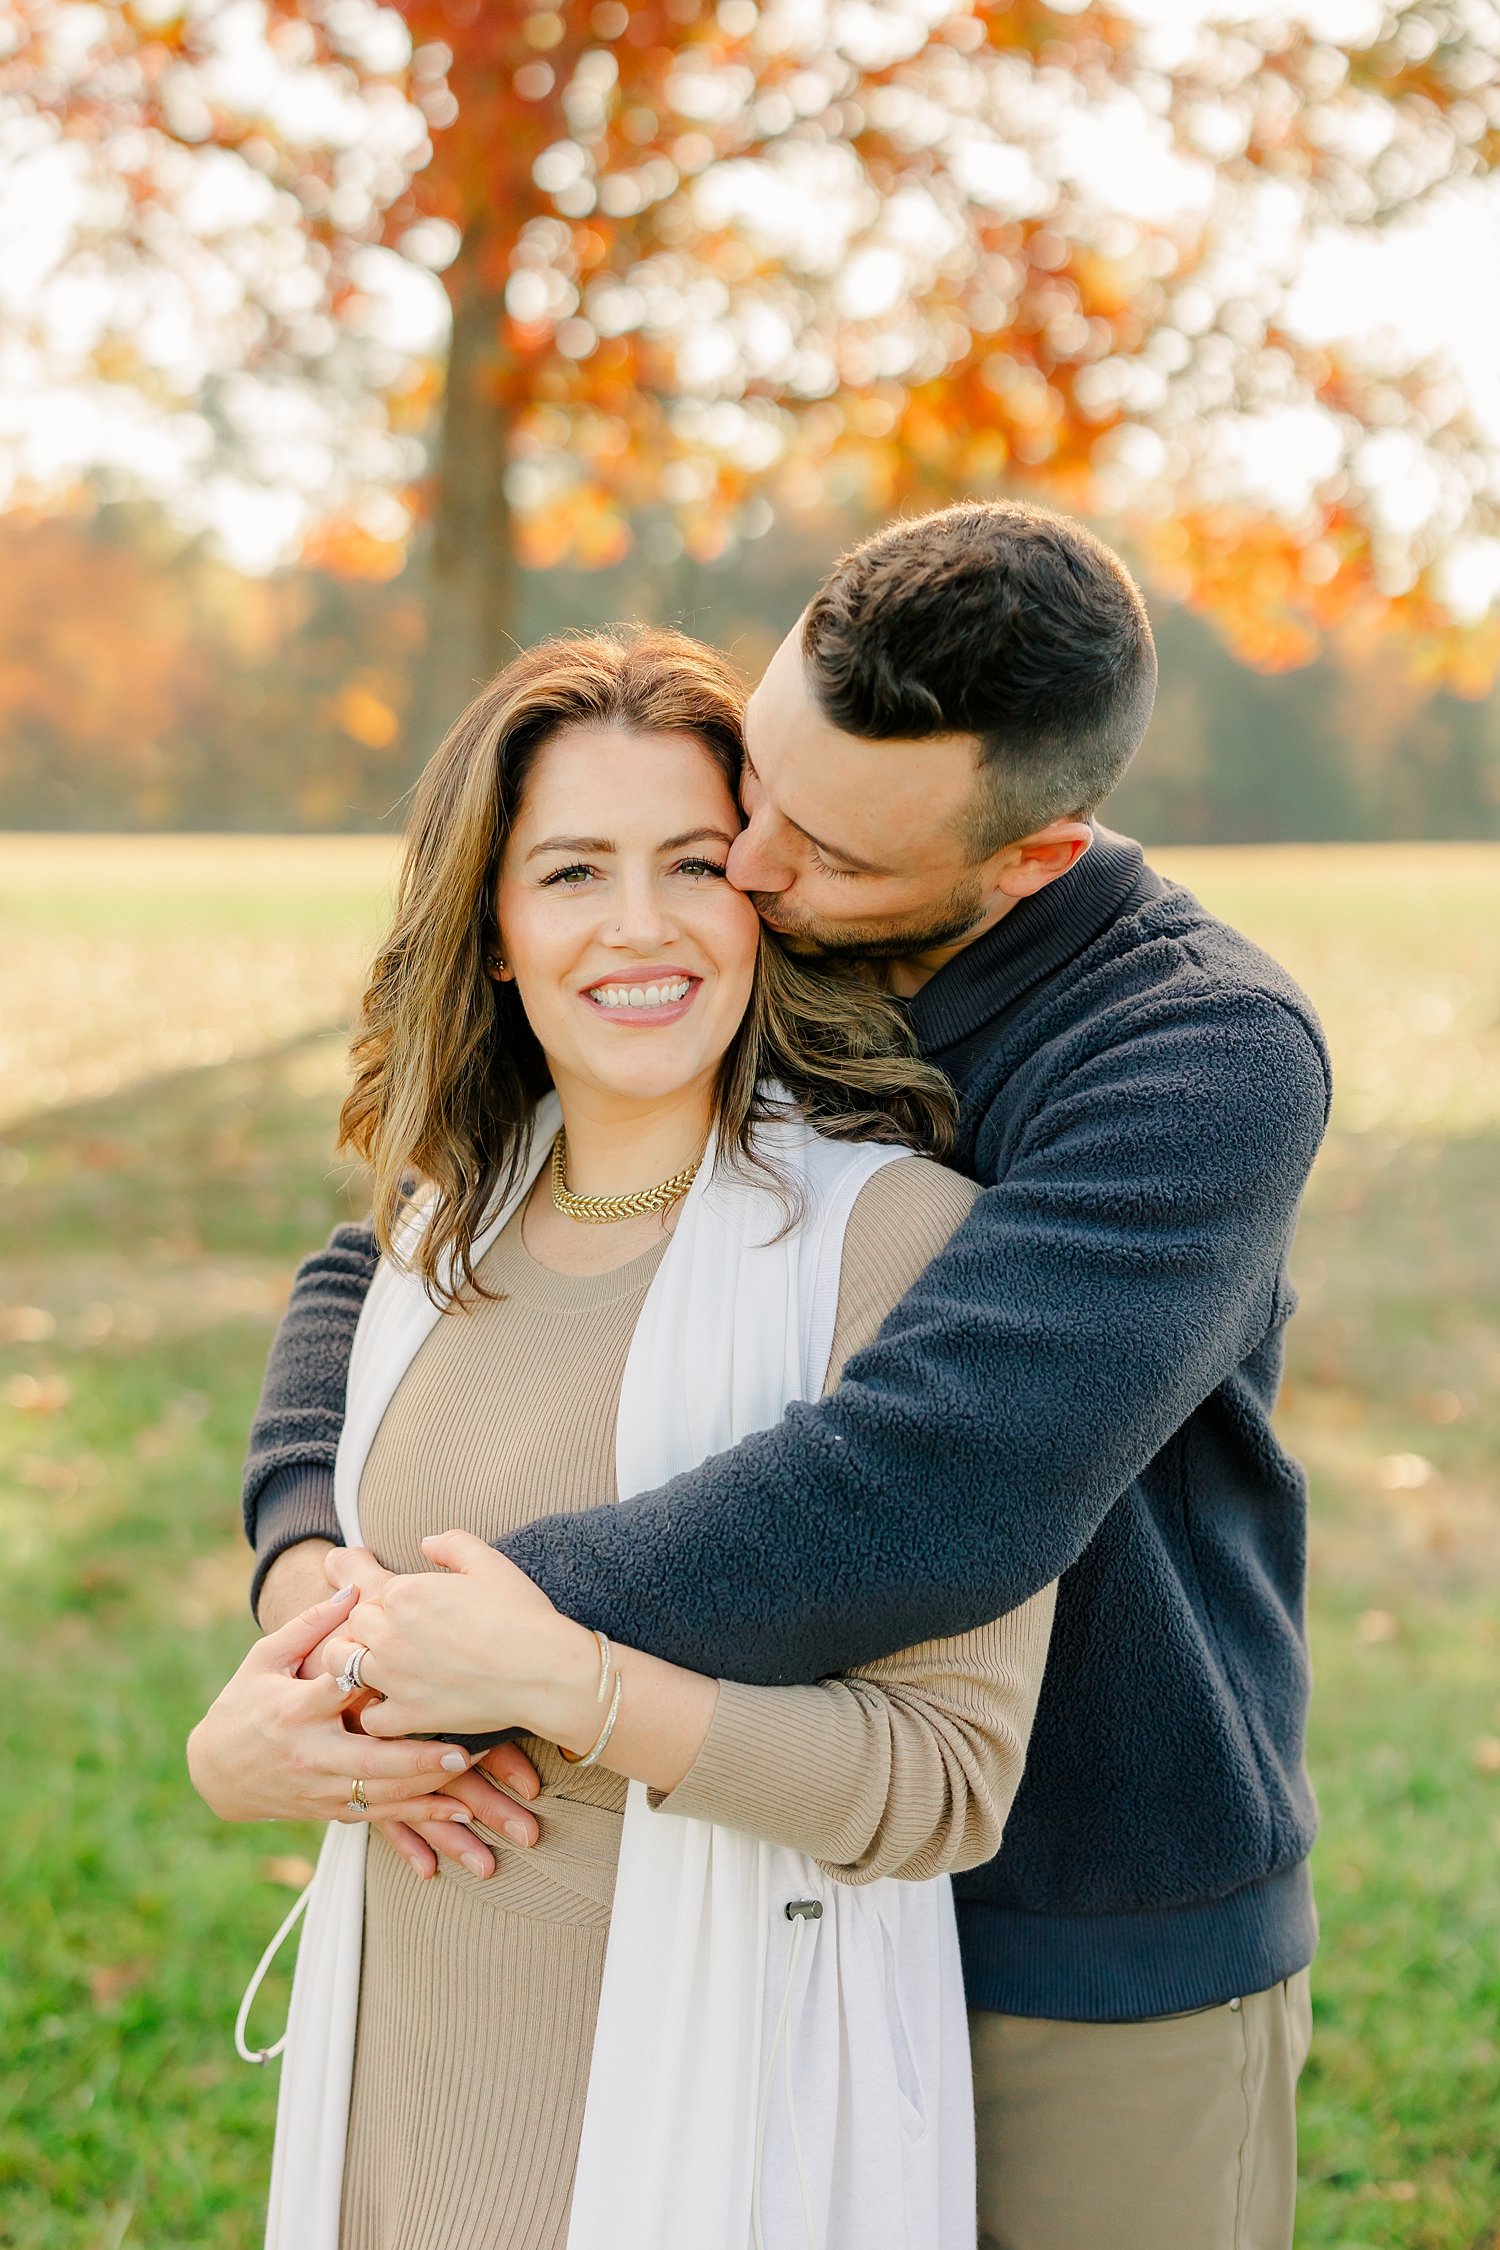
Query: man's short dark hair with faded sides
803 500 1156 860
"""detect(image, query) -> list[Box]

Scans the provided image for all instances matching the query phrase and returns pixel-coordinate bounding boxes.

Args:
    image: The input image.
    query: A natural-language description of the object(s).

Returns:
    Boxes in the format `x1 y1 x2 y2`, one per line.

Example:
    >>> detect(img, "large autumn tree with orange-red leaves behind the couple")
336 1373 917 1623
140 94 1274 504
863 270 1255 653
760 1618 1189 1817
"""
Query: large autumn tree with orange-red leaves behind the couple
0 0 1500 713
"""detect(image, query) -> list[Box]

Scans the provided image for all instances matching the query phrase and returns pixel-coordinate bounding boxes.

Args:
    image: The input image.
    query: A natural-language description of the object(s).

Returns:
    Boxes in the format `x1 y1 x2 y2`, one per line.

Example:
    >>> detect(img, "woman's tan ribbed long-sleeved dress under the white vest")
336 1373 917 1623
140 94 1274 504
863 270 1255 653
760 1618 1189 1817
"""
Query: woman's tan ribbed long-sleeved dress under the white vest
340 1161 1052 2250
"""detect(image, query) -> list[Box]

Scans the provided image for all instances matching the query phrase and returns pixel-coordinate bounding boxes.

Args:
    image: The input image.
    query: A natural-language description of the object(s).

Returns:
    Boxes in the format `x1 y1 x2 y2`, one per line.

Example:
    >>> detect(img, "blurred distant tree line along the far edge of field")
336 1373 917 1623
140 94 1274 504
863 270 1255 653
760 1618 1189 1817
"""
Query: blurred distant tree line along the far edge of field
0 506 1500 844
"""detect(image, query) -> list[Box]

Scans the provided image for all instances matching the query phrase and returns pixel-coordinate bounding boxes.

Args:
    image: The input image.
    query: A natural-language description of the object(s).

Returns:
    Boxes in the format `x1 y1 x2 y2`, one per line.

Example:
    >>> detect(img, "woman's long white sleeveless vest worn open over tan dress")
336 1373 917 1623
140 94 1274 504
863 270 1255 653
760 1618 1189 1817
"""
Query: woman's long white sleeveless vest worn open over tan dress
265 1096 976 2250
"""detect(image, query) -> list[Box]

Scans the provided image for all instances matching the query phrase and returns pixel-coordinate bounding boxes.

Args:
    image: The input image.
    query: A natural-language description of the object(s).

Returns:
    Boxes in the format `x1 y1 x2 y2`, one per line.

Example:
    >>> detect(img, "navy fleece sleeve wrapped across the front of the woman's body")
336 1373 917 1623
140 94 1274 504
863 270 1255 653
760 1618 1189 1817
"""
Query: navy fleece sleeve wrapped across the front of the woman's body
504 981 1327 1683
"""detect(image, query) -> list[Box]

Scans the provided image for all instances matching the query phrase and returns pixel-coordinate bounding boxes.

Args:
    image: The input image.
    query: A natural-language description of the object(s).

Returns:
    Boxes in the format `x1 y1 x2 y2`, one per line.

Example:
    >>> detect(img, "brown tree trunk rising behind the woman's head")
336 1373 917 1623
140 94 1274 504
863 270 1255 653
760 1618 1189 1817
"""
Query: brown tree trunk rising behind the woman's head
412 230 515 758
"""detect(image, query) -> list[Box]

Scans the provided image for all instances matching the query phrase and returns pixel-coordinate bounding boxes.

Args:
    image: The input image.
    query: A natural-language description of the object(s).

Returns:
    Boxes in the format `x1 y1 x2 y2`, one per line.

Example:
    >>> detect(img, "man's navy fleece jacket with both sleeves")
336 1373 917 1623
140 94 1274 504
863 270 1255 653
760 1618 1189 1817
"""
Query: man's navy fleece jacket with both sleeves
245 833 1329 2021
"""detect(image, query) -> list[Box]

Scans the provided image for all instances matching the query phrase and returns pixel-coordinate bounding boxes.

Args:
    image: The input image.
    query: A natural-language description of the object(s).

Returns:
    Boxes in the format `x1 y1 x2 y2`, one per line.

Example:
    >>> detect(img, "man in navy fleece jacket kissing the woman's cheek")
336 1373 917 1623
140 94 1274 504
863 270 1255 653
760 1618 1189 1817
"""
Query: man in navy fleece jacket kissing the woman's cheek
245 504 1327 2250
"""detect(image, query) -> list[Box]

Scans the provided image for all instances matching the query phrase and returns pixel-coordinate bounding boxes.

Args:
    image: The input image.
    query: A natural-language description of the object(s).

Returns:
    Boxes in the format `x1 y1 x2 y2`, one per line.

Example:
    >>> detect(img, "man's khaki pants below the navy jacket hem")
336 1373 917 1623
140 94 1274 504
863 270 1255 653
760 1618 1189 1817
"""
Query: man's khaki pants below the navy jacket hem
969 1971 1313 2250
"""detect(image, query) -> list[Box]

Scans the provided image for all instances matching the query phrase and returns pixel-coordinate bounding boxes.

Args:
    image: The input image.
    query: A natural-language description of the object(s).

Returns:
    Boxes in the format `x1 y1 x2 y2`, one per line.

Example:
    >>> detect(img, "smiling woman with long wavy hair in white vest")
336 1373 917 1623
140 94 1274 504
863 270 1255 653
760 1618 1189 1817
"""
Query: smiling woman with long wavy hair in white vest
191 635 1050 2250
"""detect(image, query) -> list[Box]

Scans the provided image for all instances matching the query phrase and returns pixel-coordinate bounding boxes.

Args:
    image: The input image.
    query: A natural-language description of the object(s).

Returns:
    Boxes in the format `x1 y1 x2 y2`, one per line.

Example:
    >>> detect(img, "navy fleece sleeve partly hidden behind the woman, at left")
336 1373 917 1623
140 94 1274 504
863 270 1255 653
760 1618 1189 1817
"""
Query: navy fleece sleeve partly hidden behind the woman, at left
243 1226 380 1609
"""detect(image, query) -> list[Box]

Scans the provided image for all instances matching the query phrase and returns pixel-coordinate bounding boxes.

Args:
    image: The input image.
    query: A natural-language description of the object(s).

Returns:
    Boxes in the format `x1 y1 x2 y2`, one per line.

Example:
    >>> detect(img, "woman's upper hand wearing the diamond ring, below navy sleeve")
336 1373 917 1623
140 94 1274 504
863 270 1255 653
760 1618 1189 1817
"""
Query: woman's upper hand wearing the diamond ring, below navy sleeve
317 1532 598 1748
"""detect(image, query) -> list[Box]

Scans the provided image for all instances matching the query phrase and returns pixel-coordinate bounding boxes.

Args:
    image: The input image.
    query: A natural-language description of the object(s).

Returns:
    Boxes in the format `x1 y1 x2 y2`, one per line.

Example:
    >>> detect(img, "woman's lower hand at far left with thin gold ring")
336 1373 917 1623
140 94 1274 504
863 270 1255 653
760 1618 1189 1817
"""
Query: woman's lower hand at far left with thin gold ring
187 1586 492 1859
